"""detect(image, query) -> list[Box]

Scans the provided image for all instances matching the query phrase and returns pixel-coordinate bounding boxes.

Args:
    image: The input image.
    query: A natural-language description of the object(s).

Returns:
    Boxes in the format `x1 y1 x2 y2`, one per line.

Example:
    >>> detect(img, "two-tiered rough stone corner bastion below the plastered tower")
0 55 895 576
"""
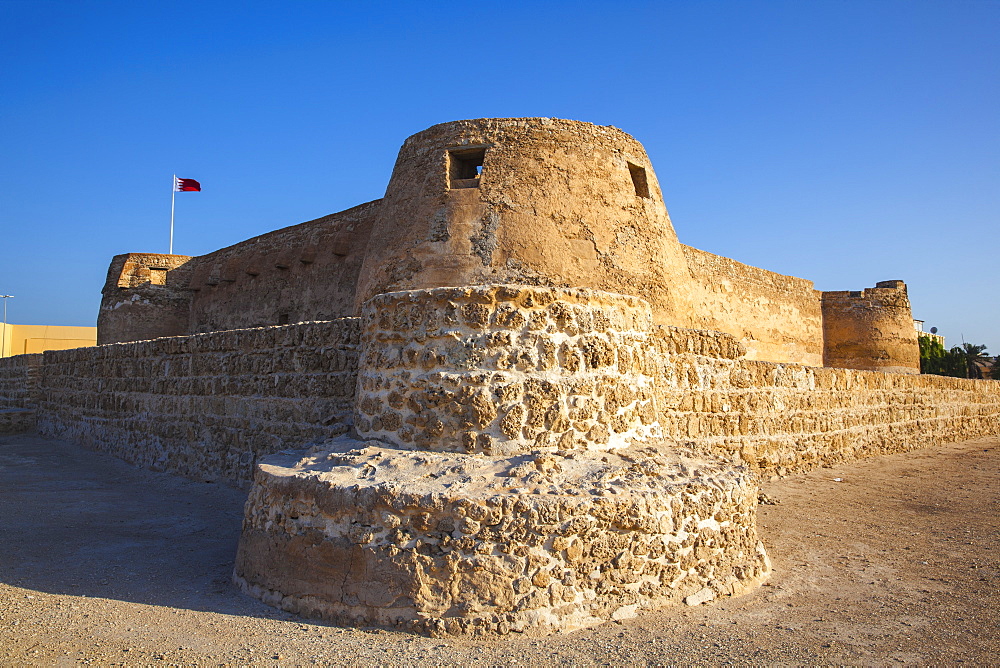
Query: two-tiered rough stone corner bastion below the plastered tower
234 285 770 634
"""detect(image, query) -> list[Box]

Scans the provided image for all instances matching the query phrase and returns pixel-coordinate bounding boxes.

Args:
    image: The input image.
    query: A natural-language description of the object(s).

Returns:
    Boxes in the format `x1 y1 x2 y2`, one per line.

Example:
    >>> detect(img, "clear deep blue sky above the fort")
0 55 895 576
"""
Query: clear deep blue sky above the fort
0 0 1000 353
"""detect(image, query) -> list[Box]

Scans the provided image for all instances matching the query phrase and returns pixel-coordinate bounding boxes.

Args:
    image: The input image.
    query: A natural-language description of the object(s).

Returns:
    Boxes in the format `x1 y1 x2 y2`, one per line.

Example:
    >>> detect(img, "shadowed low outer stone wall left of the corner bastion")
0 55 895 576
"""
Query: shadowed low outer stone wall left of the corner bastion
37 318 359 484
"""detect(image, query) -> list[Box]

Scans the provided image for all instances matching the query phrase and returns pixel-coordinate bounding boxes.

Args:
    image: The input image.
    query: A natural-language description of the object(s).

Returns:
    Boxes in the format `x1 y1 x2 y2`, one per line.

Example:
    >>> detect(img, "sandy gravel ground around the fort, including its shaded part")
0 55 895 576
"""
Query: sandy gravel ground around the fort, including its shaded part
0 435 1000 666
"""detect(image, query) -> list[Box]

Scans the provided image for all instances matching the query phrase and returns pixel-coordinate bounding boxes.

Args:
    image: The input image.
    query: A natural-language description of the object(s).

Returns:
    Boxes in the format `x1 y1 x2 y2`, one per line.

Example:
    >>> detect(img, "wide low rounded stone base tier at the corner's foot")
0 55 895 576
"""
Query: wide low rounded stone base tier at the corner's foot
234 437 770 635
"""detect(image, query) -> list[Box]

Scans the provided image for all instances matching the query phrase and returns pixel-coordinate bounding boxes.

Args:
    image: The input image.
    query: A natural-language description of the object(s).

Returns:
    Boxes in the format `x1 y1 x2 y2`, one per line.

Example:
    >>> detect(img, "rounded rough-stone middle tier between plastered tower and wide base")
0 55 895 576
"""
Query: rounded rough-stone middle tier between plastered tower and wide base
355 285 659 455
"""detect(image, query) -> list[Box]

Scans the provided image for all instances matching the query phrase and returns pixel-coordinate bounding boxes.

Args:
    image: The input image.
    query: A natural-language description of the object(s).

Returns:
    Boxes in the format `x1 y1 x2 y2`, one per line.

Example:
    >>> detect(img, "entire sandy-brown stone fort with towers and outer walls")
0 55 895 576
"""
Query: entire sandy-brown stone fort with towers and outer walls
0 118 1000 634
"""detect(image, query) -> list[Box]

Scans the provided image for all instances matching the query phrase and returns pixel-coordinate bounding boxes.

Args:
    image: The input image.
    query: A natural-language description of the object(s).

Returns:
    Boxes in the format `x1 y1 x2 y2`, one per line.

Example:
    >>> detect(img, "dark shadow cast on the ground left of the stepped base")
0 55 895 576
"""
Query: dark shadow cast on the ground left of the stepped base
0 434 282 617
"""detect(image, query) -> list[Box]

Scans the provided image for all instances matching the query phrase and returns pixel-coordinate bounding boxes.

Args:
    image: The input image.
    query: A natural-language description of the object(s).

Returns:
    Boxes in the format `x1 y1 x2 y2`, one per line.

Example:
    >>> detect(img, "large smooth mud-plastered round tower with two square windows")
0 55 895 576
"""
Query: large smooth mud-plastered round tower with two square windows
356 118 692 326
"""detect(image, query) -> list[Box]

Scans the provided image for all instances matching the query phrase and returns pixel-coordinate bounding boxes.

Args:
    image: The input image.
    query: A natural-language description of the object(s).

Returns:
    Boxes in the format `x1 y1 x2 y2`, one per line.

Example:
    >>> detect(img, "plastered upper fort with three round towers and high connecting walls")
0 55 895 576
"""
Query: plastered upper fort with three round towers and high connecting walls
99 118 918 373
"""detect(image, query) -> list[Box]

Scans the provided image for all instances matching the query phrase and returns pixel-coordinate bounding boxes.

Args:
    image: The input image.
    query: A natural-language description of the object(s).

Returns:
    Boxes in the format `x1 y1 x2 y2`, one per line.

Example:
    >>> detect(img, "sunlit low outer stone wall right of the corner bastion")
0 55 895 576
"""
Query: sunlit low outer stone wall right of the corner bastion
655 340 1000 477
